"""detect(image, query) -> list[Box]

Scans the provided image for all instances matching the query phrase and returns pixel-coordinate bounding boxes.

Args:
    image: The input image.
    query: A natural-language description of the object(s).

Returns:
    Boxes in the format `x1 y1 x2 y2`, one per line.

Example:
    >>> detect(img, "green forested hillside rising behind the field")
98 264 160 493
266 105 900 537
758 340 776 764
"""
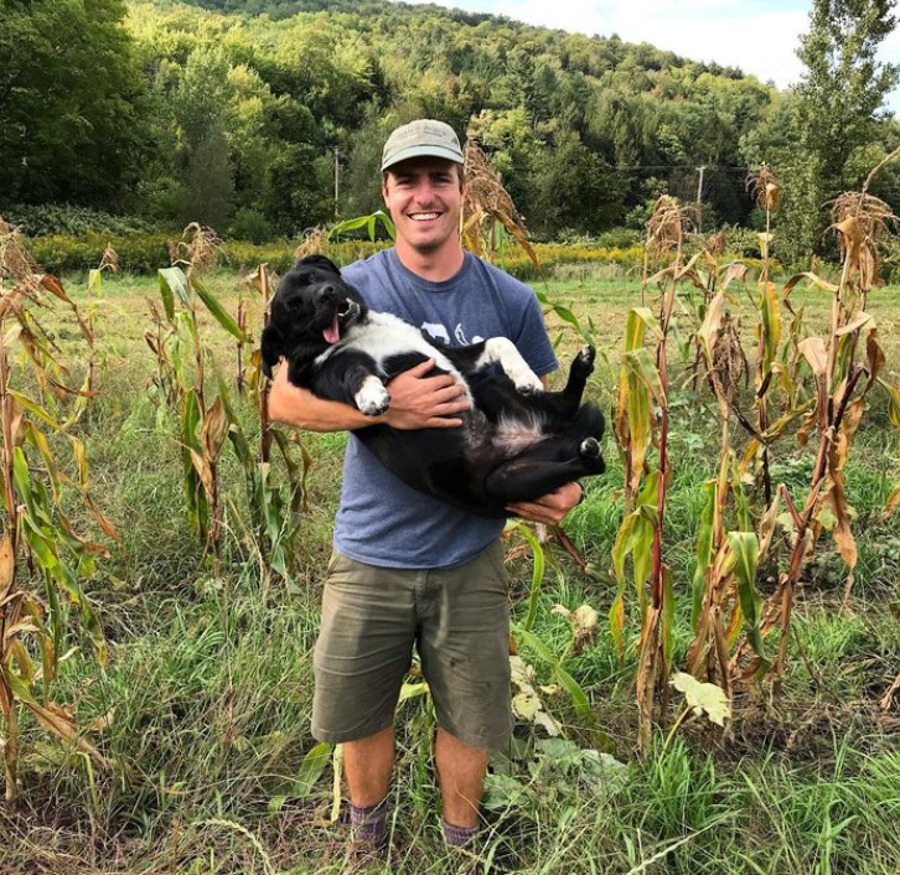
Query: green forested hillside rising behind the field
0 0 900 250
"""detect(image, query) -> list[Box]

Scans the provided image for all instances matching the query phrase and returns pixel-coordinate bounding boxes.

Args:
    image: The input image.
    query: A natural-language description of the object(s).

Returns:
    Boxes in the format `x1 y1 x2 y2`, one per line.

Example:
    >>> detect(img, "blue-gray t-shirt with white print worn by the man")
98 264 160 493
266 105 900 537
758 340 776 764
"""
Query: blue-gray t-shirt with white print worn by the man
334 249 557 568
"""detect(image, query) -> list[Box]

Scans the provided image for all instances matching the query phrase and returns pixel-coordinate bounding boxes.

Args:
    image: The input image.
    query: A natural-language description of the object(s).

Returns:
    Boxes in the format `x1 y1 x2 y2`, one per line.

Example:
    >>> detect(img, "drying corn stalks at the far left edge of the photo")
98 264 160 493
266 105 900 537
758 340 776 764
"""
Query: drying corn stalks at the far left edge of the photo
0 229 116 804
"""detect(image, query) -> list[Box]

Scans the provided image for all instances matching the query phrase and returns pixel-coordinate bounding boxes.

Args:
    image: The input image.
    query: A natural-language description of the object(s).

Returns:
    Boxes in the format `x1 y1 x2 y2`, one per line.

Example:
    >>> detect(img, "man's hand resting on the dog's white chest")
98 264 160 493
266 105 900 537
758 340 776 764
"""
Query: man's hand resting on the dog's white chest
380 359 471 430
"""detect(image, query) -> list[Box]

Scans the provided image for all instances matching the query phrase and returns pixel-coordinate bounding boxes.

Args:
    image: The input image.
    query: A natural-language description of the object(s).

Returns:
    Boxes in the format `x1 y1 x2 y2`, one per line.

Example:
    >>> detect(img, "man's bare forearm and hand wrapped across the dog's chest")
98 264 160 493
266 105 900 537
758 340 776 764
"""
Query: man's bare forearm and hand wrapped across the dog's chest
269 360 469 431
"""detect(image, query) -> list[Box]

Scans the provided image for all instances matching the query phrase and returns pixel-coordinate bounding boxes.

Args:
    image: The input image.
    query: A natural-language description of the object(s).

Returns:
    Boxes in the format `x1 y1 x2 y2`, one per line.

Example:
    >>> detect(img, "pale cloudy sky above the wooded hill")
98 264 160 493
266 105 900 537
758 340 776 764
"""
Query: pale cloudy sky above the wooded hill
390 0 900 117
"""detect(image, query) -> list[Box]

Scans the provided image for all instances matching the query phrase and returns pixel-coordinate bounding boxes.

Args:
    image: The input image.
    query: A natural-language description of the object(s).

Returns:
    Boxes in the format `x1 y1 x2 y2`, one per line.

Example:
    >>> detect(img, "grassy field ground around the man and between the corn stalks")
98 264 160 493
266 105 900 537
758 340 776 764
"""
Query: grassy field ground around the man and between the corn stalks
0 271 900 875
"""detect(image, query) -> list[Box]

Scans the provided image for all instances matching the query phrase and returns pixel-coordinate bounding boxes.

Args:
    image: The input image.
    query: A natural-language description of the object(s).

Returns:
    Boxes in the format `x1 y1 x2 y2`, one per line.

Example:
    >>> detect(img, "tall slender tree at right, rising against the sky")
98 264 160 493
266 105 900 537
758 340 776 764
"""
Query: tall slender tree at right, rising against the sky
780 0 900 257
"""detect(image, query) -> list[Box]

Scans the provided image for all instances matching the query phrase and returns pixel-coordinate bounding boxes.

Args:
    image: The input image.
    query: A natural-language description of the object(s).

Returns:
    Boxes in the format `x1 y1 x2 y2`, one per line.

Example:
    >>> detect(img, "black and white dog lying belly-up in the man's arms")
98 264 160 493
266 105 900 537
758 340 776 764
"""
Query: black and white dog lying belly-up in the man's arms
262 255 604 517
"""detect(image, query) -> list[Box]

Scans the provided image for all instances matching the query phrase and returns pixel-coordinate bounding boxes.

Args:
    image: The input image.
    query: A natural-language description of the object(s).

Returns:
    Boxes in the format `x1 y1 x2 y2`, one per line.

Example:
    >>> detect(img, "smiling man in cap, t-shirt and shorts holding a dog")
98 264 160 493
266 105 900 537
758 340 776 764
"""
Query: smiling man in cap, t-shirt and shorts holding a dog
270 119 582 845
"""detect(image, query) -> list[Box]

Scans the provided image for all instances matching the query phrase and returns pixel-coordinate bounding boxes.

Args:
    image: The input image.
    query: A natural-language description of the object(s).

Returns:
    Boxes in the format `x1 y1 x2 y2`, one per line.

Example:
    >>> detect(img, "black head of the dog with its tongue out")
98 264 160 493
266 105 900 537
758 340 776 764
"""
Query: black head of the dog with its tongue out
262 255 369 378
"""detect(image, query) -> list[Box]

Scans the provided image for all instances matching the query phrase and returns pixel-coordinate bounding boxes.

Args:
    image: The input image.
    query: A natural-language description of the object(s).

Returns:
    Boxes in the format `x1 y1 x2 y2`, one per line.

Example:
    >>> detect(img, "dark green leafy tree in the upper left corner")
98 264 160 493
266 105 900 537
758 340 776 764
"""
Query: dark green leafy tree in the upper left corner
0 0 147 210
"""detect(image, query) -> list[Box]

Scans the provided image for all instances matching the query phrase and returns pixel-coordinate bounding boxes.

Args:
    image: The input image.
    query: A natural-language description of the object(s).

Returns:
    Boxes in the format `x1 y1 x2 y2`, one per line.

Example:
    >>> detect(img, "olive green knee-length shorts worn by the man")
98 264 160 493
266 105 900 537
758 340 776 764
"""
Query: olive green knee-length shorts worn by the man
312 541 512 749
